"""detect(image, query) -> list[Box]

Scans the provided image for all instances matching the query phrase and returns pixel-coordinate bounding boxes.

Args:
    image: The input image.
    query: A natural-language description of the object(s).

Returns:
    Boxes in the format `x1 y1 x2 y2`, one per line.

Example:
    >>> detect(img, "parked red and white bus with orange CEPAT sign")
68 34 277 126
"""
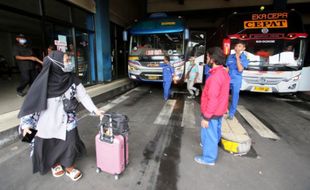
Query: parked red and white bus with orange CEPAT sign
223 11 310 93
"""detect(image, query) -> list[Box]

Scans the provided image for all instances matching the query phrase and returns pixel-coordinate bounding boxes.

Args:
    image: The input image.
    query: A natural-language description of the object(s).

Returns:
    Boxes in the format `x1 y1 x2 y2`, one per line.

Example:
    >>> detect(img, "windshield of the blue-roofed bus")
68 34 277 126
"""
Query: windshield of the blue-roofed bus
129 32 184 56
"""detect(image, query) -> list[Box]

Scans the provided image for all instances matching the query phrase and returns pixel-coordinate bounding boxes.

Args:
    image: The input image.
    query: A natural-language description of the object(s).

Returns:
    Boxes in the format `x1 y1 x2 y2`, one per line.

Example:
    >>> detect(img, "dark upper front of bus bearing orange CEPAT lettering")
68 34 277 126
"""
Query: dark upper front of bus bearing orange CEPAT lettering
226 11 304 35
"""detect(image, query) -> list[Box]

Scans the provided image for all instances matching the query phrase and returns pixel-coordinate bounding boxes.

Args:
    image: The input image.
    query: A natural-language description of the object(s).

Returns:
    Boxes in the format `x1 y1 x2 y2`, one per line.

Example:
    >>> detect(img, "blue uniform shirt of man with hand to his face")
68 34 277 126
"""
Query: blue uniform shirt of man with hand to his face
226 53 249 83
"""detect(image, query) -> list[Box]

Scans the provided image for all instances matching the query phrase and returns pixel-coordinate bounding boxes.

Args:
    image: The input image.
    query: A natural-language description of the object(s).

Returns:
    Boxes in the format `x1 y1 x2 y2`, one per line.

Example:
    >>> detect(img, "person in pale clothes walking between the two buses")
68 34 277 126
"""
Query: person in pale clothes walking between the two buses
185 57 199 98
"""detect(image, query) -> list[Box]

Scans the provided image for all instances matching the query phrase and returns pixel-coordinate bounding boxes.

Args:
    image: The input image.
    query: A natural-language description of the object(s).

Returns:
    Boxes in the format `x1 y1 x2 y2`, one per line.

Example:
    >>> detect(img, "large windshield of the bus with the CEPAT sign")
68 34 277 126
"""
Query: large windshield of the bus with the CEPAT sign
231 39 305 71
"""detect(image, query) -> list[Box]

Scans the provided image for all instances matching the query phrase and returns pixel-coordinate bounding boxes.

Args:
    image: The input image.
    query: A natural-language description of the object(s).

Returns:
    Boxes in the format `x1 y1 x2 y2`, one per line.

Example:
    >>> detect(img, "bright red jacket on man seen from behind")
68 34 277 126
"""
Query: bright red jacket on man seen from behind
200 66 230 120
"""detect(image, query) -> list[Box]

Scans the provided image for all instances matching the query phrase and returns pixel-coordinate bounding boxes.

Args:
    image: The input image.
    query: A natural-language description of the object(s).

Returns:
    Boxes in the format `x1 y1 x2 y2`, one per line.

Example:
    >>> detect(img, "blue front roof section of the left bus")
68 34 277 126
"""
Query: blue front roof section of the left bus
130 18 185 35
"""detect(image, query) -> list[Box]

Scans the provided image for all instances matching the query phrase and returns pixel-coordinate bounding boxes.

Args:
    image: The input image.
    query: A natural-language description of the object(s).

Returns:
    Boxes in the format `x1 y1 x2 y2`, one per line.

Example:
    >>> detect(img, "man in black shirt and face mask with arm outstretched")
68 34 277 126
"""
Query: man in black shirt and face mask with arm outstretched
13 34 43 96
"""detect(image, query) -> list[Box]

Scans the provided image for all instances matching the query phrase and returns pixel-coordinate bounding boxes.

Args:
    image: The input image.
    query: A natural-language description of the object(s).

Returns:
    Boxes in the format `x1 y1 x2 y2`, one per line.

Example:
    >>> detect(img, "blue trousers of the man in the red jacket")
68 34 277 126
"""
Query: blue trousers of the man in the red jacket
200 117 223 163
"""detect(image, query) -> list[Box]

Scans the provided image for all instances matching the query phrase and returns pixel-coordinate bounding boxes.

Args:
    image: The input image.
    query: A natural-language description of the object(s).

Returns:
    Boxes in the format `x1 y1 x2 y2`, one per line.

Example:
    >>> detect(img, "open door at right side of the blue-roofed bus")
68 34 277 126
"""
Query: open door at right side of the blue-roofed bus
184 31 206 83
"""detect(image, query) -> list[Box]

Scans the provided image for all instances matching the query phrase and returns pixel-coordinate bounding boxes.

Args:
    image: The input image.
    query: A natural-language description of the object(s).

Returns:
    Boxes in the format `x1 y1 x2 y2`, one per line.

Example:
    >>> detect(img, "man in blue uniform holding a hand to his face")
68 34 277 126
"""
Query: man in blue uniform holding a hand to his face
226 41 249 119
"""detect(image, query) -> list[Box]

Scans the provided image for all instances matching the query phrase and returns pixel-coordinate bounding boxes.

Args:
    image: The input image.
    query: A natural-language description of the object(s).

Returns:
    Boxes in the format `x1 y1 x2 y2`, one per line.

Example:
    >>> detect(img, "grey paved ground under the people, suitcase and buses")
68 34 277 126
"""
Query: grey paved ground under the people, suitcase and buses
0 87 310 190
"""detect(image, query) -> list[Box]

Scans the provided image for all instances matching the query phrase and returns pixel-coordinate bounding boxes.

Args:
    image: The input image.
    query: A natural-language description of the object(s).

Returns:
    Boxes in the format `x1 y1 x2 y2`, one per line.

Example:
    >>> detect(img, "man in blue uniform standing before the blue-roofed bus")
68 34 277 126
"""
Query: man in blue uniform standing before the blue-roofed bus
160 55 174 100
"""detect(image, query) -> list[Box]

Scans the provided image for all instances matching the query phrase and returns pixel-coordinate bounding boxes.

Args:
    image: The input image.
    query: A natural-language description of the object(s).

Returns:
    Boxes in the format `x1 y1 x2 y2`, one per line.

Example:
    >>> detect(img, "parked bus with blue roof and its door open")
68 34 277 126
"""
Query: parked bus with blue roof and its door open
128 13 205 83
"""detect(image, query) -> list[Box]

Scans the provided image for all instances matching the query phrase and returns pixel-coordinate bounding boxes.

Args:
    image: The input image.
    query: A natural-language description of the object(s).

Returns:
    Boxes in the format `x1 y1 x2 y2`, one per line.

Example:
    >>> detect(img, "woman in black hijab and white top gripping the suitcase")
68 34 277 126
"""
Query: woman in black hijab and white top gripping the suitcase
18 51 104 181
